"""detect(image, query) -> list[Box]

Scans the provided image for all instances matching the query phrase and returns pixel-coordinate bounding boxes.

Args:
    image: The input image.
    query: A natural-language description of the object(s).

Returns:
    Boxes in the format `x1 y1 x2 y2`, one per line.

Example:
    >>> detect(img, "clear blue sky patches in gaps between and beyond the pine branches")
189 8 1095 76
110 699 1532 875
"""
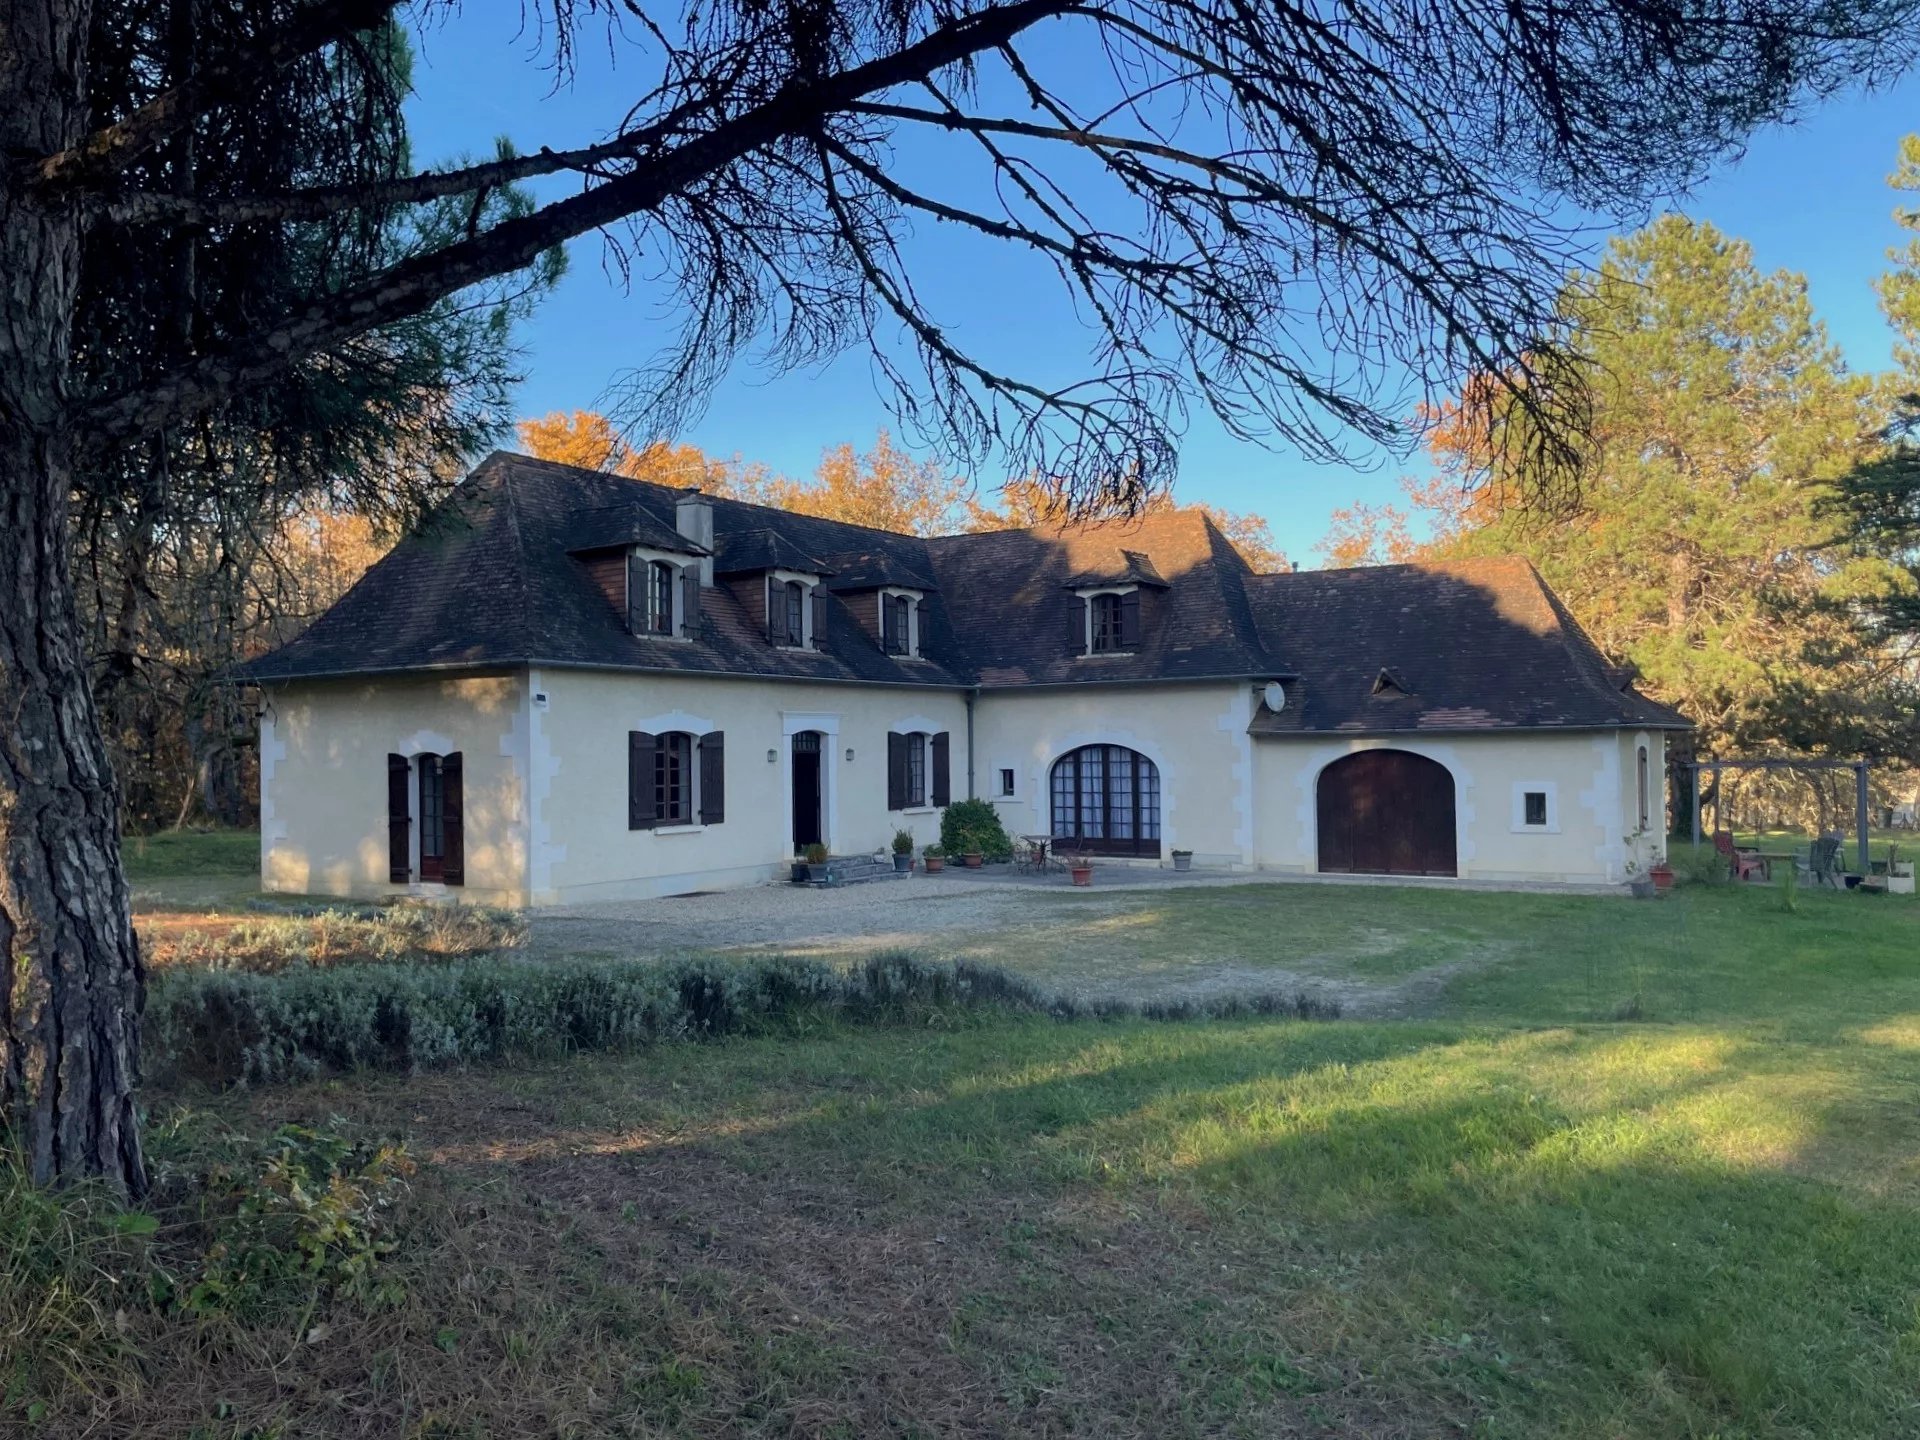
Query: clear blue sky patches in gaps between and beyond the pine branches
409 6 1920 564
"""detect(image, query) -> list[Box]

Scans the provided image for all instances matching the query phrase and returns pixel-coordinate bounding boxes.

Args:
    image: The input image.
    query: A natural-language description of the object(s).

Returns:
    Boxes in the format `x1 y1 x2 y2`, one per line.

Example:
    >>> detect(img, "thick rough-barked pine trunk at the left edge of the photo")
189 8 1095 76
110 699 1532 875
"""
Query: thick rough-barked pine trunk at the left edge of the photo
0 0 146 1194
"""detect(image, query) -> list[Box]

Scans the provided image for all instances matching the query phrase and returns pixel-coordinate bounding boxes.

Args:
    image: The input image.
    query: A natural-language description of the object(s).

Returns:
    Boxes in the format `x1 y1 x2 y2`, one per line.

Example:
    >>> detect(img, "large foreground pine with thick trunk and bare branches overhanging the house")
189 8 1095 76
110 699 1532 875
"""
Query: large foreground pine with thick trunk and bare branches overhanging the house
0 0 1914 1190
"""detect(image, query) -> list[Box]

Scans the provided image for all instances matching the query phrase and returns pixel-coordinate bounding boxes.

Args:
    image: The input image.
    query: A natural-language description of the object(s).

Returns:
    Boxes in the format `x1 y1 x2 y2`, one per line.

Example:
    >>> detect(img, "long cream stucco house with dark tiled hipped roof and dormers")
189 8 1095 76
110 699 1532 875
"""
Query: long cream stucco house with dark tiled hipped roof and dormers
246 453 1686 904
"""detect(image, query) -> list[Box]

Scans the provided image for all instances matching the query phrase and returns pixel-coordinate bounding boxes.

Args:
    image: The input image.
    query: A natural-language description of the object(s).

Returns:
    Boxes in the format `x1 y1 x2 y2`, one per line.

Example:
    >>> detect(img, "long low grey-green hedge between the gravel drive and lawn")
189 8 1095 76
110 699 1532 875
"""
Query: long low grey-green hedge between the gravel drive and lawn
144 954 1338 1085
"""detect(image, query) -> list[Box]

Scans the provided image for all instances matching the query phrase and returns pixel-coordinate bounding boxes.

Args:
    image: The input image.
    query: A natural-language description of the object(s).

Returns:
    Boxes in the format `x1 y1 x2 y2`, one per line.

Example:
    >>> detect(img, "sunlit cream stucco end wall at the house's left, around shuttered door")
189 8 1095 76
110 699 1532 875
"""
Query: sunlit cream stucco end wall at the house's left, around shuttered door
259 676 528 904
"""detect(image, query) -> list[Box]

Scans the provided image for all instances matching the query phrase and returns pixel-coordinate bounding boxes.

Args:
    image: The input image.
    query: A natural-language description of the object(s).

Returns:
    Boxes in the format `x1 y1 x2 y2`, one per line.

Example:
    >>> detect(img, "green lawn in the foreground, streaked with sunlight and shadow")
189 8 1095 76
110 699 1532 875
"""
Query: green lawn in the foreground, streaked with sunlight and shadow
15 885 1920 1440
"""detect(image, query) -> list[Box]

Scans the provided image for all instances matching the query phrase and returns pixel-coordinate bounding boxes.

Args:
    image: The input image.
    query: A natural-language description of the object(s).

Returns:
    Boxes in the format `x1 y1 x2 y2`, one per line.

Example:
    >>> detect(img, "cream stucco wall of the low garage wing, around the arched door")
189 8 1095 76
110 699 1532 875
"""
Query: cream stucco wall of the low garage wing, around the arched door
1254 730 1667 883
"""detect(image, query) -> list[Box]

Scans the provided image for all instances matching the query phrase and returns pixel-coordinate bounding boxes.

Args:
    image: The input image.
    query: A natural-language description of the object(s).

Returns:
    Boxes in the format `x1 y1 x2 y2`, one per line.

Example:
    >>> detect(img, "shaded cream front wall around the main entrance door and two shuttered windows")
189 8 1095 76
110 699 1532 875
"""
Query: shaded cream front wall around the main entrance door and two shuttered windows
532 670 966 904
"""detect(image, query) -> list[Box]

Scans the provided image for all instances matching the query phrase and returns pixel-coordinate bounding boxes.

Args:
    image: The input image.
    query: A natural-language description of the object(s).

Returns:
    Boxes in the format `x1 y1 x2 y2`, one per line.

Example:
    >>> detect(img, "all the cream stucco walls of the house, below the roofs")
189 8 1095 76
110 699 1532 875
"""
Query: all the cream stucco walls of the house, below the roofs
261 670 1667 904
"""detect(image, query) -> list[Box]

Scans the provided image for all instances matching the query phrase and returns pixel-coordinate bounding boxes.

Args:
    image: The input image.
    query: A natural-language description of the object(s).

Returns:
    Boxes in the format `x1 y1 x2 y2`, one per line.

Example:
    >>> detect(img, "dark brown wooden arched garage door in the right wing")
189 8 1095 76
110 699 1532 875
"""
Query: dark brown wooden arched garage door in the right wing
1319 751 1459 876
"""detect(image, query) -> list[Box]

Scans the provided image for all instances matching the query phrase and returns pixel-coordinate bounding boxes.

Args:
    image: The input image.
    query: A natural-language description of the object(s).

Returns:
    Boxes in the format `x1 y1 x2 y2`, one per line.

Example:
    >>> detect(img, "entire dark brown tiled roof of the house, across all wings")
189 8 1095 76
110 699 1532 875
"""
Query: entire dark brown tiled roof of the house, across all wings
240 453 1686 733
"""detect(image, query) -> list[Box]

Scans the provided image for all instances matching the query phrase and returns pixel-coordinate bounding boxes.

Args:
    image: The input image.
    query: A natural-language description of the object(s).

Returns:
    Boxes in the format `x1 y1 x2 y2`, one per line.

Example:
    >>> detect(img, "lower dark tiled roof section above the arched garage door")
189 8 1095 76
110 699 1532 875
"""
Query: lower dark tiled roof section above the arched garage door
1248 557 1688 735
